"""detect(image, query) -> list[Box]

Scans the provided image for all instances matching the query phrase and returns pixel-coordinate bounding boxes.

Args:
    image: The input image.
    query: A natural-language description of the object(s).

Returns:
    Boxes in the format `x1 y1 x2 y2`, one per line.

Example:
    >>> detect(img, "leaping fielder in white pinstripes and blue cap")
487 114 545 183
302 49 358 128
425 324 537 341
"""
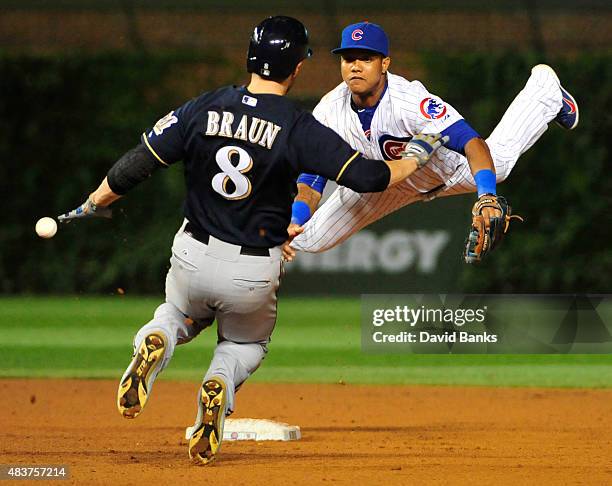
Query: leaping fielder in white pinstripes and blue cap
283 22 578 262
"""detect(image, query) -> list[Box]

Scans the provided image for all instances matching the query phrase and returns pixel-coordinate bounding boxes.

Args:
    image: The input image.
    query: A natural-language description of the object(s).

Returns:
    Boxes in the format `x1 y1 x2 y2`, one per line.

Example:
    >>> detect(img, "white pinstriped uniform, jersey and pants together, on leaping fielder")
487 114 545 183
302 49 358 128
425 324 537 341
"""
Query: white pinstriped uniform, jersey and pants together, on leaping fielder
291 64 563 253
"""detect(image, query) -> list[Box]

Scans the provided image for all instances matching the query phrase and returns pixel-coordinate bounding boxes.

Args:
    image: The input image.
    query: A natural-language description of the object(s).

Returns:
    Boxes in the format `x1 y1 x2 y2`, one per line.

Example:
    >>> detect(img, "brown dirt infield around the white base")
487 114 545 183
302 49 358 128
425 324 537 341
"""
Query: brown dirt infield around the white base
0 380 612 486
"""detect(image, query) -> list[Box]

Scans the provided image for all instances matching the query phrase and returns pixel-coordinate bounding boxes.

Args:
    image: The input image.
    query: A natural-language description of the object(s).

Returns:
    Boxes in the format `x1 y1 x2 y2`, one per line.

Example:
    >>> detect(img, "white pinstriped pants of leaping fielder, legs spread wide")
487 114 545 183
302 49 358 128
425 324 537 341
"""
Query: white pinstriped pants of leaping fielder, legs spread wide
291 66 562 253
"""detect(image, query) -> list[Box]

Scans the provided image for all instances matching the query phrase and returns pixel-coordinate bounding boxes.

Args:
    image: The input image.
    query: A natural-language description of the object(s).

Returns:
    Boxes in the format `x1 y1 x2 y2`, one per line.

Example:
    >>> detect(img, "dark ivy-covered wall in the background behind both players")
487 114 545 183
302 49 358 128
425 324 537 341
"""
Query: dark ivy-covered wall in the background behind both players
0 0 612 294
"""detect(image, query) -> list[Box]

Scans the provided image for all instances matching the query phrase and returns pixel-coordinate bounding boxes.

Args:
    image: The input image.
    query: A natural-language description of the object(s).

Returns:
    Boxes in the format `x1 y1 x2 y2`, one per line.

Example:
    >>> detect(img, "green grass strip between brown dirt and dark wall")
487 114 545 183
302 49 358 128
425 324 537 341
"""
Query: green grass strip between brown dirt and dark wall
0 297 612 387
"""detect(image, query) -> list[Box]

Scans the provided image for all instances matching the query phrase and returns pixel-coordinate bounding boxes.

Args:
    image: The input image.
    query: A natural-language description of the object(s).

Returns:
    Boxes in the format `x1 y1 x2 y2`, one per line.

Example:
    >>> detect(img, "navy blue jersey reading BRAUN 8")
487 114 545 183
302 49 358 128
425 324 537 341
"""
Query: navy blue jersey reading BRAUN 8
142 86 361 248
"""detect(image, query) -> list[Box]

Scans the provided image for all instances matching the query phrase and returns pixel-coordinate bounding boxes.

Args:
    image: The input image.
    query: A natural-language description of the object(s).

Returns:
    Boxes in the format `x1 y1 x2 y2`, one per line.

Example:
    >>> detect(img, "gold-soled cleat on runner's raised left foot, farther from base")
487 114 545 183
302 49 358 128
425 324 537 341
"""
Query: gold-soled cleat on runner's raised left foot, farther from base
117 333 167 418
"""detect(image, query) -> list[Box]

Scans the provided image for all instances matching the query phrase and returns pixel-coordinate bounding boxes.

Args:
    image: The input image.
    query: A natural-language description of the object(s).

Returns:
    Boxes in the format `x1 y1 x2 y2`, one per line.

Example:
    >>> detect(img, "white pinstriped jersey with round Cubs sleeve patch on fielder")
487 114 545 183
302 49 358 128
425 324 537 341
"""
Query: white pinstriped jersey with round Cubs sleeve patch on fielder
313 72 466 192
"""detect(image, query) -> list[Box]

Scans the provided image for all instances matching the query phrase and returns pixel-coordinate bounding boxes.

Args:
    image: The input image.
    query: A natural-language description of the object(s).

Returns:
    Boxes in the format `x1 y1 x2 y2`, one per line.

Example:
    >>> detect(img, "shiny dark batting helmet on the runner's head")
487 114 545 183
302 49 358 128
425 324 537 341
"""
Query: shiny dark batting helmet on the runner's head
247 15 312 80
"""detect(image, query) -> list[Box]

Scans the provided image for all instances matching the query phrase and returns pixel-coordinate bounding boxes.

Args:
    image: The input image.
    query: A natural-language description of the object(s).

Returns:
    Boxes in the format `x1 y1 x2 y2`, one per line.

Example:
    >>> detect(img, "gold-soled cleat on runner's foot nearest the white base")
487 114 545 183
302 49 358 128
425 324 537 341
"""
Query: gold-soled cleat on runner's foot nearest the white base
189 377 226 464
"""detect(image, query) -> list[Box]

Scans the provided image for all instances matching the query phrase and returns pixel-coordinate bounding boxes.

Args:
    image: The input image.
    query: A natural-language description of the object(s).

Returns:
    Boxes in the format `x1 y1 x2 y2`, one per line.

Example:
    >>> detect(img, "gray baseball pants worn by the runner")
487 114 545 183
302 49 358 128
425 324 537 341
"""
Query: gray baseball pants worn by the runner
134 225 282 414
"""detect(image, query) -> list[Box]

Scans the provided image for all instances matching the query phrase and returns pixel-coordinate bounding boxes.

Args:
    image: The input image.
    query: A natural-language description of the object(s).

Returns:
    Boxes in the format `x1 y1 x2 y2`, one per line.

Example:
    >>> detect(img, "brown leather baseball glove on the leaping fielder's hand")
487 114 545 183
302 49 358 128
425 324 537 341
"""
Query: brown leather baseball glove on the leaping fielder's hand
463 194 523 263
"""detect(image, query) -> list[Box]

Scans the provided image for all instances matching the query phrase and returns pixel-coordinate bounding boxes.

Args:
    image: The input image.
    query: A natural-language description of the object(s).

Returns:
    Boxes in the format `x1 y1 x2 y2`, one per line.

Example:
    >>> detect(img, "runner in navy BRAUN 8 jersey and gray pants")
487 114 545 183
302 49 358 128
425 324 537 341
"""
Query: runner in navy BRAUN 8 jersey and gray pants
59 17 445 464
